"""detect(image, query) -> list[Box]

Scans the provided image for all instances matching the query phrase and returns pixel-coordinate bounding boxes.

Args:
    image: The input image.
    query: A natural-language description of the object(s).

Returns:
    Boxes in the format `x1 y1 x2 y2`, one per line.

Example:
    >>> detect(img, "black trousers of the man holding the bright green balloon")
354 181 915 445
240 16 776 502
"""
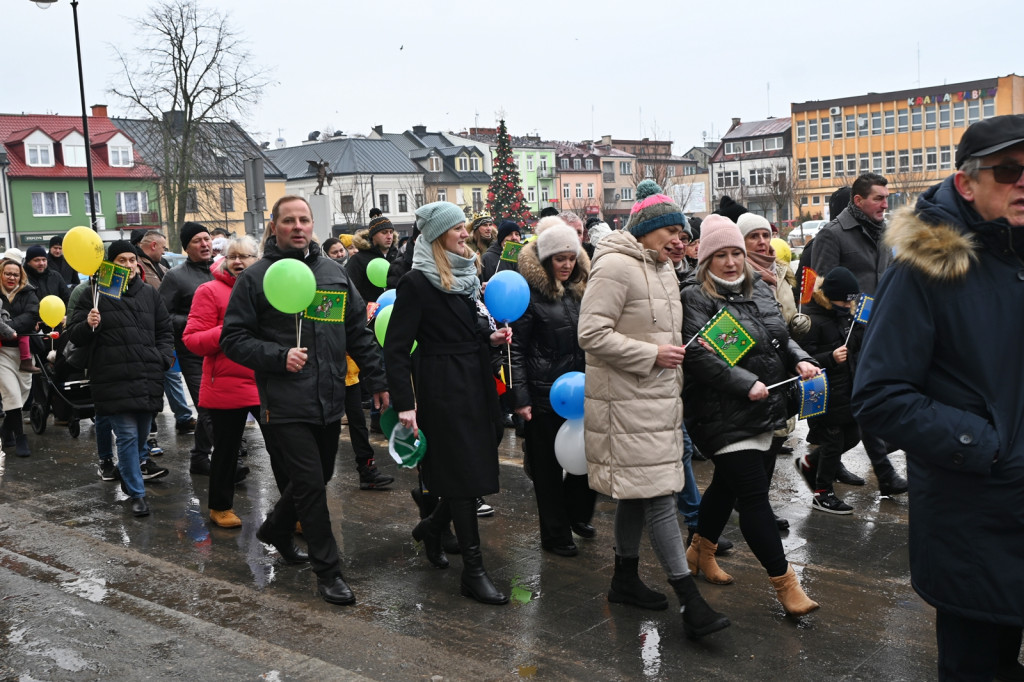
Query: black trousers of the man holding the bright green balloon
263 421 341 579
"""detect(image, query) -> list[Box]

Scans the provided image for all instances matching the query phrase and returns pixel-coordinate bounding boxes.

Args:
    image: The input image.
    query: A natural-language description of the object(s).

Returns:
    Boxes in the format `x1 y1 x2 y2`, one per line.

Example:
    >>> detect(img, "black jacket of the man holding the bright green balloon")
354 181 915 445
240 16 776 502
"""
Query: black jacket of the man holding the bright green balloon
222 237 384 425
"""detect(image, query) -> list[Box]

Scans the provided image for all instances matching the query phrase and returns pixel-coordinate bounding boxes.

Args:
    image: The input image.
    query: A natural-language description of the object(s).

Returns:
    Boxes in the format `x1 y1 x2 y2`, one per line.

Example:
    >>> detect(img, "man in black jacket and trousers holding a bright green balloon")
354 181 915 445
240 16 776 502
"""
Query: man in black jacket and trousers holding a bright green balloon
220 196 388 604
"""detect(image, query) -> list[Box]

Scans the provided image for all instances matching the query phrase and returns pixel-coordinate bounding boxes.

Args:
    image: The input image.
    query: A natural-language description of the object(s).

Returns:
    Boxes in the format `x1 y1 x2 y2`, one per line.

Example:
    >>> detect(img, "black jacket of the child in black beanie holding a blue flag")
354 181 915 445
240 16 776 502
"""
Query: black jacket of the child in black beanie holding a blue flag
800 290 864 424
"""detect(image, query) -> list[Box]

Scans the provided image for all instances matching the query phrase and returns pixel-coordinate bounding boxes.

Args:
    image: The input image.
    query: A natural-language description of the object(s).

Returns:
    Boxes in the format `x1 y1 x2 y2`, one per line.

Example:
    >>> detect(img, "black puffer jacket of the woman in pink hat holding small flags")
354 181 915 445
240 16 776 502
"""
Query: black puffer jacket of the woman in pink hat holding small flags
682 275 813 454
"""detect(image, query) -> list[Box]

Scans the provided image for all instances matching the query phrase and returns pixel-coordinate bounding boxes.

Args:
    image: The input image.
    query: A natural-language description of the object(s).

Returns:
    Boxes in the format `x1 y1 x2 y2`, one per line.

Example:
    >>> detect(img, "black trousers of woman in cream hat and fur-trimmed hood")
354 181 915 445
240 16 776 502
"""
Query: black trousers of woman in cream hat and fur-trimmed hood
526 405 597 547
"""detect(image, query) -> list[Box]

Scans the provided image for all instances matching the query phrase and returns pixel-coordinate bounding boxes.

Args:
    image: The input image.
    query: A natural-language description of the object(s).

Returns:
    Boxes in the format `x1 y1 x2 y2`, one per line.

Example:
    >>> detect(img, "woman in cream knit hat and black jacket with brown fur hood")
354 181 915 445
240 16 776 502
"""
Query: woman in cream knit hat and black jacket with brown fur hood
512 217 596 556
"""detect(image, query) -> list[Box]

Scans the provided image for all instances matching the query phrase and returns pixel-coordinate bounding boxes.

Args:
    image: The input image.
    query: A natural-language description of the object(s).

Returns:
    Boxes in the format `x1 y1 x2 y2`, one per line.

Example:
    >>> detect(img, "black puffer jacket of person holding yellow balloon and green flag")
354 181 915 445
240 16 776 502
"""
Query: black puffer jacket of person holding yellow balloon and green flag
68 275 174 415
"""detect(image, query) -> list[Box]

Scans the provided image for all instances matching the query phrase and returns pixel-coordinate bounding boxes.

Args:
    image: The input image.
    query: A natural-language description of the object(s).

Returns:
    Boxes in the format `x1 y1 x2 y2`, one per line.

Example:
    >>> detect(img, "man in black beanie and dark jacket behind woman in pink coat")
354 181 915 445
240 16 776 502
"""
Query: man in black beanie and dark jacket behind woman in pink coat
159 222 213 476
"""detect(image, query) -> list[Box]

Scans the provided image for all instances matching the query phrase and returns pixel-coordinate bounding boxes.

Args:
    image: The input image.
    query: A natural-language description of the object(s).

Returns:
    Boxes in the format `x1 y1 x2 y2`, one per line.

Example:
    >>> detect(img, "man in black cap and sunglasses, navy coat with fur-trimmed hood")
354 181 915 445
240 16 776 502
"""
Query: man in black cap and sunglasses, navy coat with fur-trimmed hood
851 115 1024 680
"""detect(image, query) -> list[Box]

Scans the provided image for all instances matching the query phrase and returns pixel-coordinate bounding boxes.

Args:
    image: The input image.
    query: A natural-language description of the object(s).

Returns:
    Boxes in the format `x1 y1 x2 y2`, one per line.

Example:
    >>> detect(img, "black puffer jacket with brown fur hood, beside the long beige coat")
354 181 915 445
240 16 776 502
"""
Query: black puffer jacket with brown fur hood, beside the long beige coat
512 242 590 412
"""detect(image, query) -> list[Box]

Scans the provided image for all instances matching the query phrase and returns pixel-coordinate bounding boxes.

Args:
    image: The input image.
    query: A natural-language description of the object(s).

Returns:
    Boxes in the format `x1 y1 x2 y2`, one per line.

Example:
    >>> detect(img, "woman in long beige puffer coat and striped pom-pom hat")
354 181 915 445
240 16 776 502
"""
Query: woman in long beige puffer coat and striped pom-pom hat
579 181 729 638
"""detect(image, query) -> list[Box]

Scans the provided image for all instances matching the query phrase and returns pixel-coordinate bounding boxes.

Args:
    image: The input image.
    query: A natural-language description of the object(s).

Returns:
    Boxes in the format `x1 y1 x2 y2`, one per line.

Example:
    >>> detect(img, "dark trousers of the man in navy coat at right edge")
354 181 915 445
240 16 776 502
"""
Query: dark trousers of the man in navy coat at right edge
935 611 1021 682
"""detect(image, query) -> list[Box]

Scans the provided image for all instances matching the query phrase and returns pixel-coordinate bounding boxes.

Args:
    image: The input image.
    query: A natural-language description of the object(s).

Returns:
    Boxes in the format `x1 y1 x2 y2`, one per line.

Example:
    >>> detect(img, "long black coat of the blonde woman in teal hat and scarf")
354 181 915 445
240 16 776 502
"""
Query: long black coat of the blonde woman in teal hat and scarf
385 270 503 498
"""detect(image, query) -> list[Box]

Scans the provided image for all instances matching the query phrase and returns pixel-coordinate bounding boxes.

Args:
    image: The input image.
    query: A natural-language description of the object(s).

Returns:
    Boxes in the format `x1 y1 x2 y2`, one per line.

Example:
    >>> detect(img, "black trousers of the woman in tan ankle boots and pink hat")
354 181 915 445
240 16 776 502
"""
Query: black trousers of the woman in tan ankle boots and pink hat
697 450 788 578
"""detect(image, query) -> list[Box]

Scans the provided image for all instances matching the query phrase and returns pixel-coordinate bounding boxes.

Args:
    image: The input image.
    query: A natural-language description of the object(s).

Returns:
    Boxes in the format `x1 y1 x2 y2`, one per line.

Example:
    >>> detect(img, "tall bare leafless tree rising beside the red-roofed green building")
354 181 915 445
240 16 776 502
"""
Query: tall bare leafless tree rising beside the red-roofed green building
113 0 267 243
